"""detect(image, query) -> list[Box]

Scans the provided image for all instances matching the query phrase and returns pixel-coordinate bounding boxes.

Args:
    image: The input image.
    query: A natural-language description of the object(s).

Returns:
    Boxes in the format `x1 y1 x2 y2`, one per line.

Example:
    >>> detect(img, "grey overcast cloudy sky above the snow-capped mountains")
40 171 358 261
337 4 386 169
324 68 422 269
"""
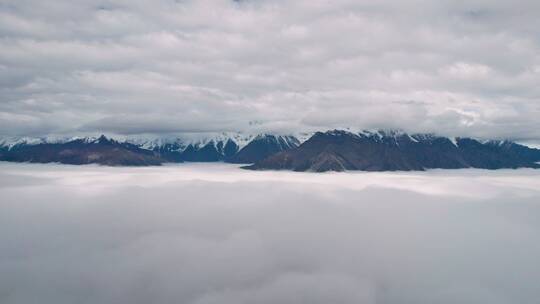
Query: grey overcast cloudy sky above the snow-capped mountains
0 0 540 141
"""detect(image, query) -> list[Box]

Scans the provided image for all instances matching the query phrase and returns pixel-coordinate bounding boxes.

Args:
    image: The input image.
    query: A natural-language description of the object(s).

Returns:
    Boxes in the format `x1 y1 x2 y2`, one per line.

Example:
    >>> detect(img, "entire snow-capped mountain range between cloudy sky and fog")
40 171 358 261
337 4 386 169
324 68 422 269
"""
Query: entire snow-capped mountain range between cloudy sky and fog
0 130 540 172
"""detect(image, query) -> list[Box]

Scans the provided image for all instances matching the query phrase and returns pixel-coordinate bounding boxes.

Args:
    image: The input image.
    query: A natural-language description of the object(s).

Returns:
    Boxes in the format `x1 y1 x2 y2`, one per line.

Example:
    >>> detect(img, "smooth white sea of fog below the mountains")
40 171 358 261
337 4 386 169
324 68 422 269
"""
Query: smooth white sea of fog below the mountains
0 163 540 304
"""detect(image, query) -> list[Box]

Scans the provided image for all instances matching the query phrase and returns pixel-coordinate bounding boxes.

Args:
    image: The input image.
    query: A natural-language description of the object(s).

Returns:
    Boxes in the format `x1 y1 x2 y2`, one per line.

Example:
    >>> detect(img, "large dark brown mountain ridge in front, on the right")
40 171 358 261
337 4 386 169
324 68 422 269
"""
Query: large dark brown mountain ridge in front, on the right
246 130 540 172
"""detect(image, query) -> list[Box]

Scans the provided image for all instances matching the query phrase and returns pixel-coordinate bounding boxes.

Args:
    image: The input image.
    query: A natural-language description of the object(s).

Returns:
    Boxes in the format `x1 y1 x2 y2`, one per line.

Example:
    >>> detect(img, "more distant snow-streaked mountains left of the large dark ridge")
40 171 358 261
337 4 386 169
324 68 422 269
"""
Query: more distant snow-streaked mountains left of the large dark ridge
0 133 300 165
